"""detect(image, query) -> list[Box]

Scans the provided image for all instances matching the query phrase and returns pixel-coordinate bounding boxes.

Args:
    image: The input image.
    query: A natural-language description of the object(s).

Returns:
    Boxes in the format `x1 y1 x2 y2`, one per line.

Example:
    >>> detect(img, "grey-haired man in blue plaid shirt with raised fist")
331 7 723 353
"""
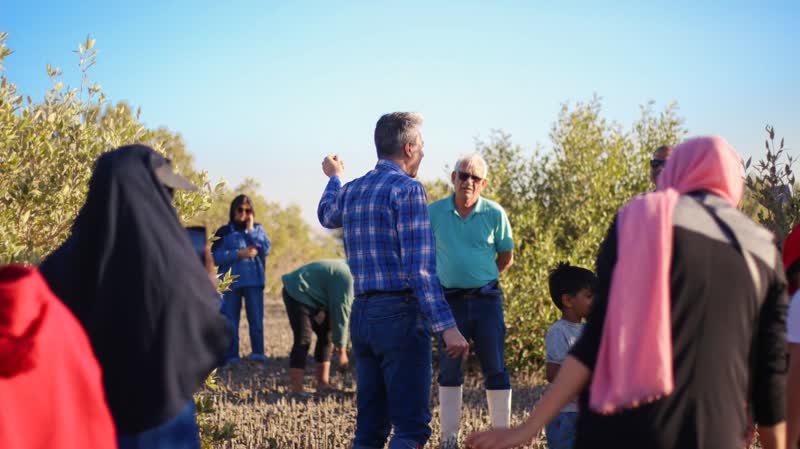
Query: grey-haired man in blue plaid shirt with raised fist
317 112 469 449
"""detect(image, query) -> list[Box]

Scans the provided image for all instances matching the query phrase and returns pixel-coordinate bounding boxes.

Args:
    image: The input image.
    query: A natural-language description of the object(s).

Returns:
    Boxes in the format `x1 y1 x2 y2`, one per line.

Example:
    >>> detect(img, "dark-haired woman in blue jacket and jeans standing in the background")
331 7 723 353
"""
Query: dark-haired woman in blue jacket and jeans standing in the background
211 195 272 364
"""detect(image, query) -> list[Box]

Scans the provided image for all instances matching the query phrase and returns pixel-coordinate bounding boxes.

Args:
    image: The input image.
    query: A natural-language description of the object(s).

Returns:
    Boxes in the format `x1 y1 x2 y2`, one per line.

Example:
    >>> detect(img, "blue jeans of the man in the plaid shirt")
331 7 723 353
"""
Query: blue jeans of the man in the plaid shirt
350 294 433 449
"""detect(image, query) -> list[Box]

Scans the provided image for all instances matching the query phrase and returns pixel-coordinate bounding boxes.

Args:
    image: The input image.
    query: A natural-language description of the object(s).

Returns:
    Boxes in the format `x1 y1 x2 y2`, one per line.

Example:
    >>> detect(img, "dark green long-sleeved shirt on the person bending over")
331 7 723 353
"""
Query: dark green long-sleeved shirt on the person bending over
281 260 353 348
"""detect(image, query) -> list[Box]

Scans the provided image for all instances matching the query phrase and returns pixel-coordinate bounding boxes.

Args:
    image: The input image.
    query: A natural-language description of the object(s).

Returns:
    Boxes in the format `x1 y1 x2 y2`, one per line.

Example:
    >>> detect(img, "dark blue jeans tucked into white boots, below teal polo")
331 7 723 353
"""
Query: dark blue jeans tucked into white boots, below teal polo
439 296 511 390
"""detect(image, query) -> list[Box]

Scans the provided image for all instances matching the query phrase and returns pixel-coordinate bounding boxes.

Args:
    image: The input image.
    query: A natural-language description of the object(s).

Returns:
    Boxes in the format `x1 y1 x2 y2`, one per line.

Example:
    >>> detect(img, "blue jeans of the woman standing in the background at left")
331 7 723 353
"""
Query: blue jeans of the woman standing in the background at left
222 287 264 360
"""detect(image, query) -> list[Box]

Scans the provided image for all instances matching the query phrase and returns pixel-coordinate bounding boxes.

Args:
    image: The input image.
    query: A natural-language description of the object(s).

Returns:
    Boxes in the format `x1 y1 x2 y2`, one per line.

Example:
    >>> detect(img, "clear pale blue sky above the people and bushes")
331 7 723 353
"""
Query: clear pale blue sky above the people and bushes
0 0 800 227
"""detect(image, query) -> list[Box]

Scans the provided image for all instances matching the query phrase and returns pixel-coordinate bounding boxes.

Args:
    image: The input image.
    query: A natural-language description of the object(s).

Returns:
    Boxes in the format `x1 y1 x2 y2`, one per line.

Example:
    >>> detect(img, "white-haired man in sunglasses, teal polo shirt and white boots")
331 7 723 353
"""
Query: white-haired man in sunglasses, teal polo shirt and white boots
429 154 514 448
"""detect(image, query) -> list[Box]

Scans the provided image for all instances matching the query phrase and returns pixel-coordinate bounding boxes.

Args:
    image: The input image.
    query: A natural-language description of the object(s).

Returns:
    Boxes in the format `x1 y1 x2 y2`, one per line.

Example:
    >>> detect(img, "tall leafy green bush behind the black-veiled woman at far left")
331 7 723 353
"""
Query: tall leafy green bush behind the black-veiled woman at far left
0 33 221 264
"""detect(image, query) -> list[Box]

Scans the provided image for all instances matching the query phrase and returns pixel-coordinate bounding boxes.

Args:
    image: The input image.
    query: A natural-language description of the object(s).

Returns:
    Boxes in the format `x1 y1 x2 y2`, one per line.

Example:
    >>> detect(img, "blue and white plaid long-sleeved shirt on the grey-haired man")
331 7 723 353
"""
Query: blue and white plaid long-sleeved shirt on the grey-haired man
317 159 456 332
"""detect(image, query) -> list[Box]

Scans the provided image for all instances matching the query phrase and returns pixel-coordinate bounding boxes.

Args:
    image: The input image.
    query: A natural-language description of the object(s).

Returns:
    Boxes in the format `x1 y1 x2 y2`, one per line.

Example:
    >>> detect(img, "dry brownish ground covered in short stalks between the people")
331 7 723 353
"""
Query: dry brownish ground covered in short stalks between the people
198 298 546 449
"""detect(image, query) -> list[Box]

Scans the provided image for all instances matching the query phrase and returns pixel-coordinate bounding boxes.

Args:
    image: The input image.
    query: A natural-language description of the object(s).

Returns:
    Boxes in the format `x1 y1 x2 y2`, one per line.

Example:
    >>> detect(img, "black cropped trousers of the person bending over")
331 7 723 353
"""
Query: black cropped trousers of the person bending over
282 289 333 369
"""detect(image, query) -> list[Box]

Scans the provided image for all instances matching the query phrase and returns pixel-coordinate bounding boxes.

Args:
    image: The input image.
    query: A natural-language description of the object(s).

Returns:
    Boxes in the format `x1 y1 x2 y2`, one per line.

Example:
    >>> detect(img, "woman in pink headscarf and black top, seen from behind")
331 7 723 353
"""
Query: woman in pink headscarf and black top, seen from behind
467 137 787 449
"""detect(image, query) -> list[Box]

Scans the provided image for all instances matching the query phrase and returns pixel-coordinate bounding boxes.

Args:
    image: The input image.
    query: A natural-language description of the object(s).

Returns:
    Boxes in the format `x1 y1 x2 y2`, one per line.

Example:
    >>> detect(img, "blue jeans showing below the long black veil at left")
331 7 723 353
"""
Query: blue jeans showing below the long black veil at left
117 400 200 449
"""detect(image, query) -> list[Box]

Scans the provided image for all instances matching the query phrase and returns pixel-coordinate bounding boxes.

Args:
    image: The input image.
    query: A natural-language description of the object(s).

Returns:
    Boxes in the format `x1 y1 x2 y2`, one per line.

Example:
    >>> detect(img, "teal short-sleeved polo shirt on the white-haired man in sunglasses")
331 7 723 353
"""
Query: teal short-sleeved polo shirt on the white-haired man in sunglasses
428 195 514 288
